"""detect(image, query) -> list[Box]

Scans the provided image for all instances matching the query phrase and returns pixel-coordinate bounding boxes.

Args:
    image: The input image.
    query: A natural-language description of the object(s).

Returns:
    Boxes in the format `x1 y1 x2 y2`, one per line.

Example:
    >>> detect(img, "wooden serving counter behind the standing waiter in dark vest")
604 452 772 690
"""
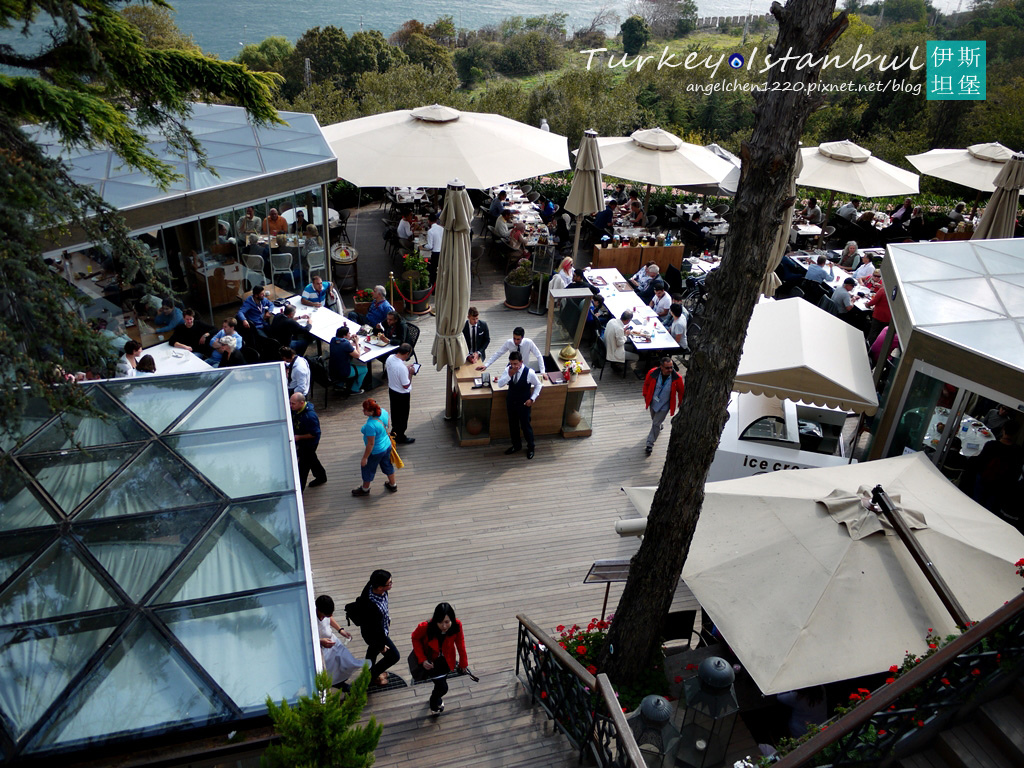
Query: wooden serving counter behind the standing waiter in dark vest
453 353 597 445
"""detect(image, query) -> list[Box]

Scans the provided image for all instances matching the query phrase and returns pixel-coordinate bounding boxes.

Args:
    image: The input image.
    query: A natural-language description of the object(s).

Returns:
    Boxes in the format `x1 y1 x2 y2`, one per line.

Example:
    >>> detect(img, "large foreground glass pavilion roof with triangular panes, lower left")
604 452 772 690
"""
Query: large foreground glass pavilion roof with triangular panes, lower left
0 365 321 762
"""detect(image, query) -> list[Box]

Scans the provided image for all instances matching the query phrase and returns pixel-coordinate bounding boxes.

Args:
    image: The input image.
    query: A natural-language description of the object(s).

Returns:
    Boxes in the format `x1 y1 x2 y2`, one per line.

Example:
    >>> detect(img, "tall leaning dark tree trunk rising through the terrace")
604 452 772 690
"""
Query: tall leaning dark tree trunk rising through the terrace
600 0 847 682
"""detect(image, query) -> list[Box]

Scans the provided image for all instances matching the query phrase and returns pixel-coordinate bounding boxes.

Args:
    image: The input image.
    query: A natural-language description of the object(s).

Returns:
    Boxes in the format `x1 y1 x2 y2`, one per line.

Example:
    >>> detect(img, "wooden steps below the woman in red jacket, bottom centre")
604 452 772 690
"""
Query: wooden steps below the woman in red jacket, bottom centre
364 670 579 768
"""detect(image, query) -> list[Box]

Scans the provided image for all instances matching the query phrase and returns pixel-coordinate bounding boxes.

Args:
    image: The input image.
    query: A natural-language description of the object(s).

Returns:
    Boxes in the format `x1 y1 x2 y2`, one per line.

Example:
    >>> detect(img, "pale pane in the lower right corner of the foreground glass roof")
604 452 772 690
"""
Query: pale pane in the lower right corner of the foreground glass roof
158 587 314 712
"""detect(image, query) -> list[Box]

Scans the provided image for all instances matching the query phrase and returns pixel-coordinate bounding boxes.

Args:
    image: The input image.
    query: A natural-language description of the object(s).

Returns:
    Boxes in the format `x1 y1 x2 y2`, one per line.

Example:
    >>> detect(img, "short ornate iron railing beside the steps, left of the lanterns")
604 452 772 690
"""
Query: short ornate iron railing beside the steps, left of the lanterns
515 614 645 768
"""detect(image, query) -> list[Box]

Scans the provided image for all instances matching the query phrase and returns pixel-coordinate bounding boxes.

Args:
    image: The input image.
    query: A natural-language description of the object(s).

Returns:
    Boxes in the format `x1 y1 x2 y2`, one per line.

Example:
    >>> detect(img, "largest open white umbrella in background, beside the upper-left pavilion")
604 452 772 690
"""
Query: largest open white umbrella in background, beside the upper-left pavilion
323 104 569 189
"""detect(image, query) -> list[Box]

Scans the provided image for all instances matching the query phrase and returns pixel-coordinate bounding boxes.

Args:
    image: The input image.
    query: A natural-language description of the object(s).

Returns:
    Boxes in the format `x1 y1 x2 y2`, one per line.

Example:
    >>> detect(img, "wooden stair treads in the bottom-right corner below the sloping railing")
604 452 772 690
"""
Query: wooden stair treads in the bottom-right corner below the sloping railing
899 680 1024 768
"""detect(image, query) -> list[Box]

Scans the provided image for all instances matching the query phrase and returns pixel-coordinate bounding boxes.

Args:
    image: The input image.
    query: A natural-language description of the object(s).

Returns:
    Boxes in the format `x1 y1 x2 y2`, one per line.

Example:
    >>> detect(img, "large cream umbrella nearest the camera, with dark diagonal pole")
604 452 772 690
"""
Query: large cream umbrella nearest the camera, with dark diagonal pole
626 454 1024 693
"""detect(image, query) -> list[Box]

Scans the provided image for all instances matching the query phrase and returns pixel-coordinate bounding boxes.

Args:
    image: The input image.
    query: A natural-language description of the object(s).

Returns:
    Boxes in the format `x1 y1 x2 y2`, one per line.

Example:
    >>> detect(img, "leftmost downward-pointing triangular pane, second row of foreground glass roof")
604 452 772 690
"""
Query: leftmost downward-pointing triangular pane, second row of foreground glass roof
20 443 141 514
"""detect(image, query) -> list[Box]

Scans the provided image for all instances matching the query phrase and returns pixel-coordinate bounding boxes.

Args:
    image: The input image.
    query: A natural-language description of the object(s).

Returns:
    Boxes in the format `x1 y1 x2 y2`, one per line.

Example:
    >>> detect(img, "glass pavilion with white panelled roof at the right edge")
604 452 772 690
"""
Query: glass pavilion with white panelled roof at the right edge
868 239 1024 467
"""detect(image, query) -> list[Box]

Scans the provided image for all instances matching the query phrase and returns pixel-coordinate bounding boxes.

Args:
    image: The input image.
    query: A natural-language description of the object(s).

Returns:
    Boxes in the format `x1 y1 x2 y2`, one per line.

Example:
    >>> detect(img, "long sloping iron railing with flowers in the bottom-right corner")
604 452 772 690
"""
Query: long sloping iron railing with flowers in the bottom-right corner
775 595 1024 768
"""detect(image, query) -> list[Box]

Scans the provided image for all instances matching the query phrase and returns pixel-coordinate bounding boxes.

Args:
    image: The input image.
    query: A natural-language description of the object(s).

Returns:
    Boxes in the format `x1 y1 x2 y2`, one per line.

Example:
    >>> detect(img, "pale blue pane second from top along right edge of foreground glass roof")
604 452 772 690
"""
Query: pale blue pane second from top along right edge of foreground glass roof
165 423 295 499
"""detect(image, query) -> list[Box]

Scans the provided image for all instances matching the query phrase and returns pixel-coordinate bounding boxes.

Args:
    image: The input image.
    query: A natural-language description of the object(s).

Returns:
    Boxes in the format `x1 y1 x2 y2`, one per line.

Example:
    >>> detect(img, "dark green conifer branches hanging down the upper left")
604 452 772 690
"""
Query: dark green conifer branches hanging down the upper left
0 0 278 443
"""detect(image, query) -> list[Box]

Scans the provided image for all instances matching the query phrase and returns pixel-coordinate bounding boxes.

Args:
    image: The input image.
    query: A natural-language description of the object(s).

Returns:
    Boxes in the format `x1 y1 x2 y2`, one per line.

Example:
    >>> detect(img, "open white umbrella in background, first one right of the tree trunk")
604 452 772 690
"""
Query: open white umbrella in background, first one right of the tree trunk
797 140 919 198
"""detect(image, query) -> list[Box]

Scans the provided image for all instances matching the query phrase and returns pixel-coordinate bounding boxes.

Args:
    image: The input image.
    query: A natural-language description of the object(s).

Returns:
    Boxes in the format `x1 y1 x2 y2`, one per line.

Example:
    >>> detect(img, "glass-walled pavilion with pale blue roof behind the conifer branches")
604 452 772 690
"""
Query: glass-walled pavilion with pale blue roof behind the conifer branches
31 103 338 339
